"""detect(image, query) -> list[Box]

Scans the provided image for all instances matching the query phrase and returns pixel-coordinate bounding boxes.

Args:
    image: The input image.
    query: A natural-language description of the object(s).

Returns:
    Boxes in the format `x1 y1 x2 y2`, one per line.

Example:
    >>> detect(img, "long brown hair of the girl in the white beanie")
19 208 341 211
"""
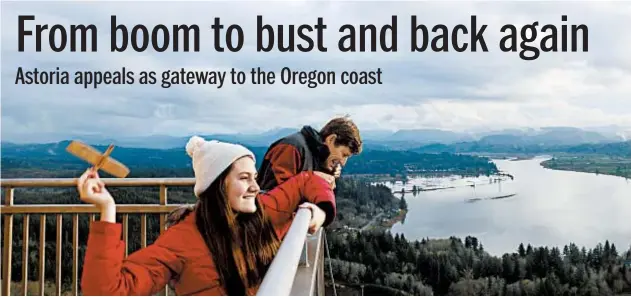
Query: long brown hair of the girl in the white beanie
195 165 280 295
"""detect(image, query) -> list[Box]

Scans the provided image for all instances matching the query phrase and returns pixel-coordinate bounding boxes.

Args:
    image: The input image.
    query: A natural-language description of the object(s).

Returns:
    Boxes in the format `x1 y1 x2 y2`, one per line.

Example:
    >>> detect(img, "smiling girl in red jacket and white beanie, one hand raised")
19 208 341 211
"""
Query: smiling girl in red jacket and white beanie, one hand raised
77 136 335 296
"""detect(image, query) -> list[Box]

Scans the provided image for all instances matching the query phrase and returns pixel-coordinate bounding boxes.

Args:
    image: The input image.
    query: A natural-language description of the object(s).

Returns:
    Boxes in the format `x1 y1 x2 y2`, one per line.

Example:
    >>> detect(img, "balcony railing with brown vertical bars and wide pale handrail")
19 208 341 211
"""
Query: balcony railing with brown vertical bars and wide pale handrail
0 178 325 296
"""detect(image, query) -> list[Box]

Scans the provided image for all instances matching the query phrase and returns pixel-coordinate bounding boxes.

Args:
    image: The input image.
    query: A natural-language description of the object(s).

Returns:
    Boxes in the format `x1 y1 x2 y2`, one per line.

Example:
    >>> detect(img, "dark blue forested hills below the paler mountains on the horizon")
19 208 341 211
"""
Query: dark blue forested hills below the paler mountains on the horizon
2 141 497 178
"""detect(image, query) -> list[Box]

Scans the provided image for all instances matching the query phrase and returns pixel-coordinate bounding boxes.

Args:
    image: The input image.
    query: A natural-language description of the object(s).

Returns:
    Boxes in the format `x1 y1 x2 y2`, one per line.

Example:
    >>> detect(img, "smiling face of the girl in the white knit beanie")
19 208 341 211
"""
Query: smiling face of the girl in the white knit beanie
226 157 261 213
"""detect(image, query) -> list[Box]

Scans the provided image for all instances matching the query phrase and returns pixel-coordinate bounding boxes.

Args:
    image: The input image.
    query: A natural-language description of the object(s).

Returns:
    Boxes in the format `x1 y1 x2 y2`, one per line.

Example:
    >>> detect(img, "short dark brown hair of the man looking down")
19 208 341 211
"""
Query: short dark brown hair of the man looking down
320 115 362 155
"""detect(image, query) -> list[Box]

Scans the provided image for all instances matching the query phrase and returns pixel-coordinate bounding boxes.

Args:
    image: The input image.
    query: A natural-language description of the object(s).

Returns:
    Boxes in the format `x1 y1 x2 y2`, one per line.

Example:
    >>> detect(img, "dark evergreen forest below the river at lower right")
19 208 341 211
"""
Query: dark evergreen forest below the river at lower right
327 232 631 296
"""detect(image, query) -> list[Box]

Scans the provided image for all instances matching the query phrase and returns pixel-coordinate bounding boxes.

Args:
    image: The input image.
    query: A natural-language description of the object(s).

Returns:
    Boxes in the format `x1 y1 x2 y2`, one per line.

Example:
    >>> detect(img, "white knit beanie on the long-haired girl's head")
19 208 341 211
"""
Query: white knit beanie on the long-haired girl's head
186 136 256 197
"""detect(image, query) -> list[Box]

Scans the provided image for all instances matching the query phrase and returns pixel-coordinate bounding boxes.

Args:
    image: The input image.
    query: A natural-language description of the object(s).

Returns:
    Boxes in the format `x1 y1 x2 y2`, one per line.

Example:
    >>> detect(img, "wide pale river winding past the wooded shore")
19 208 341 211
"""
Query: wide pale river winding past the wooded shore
384 158 631 256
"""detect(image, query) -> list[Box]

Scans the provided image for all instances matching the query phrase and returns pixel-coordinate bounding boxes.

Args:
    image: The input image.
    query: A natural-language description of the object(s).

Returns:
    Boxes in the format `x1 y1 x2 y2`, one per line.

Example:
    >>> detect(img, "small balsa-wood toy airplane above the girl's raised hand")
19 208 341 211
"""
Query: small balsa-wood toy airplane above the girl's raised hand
66 140 129 178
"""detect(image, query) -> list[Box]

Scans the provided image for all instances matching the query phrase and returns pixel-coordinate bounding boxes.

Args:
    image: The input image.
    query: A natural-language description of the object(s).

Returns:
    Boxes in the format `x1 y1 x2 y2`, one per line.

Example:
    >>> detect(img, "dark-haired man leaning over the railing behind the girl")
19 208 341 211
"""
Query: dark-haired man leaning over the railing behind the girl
257 117 362 226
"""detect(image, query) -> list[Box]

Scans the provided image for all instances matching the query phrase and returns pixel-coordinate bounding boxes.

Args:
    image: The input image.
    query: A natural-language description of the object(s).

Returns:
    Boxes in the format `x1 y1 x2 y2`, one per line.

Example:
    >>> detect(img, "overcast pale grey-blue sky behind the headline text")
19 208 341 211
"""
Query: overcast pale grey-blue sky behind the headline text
1 1 631 140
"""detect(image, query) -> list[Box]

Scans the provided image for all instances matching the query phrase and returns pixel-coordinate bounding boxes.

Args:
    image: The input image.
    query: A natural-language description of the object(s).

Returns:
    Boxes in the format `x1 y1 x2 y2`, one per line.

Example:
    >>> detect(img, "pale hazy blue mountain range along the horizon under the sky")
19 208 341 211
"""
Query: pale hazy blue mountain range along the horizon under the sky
2 126 631 150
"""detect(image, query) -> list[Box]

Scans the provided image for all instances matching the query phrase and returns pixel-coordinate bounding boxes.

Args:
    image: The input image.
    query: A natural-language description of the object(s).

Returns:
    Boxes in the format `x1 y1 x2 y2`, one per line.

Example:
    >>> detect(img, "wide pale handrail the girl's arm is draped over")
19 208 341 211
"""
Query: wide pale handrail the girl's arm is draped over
257 209 311 296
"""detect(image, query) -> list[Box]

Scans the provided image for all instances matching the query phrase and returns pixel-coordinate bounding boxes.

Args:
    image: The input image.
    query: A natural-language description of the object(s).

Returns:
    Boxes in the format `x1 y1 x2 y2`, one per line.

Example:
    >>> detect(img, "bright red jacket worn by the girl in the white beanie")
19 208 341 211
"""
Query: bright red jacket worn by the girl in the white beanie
81 172 335 296
